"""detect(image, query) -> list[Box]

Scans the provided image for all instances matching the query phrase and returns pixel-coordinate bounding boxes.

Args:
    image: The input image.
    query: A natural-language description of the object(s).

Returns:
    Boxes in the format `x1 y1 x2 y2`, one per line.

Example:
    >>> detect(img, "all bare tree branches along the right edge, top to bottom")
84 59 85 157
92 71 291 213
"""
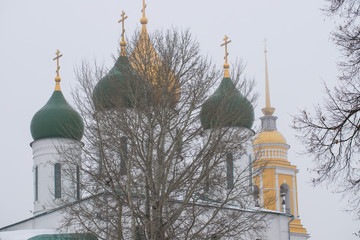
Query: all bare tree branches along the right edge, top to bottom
293 0 360 227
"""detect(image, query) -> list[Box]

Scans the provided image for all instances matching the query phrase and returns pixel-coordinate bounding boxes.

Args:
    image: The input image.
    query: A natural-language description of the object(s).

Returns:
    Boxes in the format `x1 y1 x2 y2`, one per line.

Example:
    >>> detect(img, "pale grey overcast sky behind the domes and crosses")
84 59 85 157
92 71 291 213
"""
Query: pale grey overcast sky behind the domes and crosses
0 0 360 240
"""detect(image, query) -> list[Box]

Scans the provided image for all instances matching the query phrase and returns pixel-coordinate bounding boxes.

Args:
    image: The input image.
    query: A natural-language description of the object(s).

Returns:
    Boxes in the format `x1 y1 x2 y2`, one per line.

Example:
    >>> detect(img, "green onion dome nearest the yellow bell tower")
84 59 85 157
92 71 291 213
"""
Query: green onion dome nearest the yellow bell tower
200 76 254 129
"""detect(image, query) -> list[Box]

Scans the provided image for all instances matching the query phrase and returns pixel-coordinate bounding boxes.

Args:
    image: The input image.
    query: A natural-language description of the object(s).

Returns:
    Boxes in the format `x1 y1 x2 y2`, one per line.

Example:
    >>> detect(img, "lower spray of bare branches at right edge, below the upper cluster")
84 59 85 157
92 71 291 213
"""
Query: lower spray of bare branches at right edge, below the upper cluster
293 81 360 206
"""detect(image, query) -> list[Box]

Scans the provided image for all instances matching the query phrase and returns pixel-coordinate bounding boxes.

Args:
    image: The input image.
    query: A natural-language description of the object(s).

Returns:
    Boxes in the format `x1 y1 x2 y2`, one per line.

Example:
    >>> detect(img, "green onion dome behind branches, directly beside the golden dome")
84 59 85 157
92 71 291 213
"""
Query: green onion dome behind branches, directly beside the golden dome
93 56 148 110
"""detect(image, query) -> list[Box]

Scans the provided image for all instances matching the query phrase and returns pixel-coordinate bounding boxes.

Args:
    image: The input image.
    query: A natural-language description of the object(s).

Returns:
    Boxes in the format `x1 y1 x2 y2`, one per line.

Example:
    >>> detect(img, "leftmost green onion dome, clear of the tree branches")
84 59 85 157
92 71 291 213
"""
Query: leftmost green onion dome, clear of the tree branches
30 88 84 141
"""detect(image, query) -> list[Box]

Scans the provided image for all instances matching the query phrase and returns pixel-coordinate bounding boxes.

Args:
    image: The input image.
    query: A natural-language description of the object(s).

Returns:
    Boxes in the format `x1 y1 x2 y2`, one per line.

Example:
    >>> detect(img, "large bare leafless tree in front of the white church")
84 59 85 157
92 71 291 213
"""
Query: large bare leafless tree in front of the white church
59 30 265 240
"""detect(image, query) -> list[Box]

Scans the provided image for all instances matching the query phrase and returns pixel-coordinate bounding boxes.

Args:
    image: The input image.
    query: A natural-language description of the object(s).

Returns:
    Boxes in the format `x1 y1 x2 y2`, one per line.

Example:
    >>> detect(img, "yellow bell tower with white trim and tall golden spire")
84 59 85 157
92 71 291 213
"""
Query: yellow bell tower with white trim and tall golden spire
253 43 309 239
